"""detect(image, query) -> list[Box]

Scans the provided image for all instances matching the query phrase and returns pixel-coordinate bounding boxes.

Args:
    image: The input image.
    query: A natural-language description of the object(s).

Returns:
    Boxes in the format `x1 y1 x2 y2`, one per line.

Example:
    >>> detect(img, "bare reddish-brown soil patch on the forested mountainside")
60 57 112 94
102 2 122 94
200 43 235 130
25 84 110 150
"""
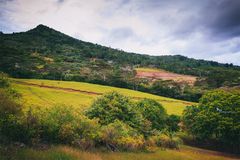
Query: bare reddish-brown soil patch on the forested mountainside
136 70 197 85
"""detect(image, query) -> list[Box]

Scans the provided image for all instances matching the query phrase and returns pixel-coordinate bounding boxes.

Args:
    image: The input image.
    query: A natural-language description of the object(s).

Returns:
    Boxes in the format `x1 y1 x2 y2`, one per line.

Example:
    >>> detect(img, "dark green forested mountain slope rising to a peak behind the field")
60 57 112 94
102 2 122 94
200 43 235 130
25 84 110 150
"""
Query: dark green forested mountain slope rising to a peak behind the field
0 25 240 101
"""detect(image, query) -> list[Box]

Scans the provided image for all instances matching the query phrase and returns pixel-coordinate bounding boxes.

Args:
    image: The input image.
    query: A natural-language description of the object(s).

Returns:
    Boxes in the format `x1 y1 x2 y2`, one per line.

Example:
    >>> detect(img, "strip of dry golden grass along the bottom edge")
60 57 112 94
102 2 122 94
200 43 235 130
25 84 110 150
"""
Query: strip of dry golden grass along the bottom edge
0 146 239 160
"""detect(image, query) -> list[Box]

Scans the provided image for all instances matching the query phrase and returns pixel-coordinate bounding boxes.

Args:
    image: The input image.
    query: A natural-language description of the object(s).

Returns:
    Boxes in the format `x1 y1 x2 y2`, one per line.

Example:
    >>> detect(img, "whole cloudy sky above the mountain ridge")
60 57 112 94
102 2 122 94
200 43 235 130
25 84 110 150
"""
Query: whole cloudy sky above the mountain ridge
0 0 240 65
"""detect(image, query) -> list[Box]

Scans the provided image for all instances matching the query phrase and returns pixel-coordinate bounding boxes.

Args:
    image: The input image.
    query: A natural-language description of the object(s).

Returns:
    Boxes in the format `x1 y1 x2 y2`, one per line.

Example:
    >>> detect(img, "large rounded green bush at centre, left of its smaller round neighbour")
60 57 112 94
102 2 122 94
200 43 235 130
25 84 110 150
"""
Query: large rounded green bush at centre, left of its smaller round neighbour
87 92 144 129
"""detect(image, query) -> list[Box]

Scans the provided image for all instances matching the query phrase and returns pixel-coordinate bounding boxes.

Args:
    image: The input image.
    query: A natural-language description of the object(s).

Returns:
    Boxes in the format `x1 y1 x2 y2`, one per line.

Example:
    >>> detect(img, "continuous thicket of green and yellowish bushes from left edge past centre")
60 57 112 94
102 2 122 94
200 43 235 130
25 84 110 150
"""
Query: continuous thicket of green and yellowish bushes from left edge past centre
0 75 180 152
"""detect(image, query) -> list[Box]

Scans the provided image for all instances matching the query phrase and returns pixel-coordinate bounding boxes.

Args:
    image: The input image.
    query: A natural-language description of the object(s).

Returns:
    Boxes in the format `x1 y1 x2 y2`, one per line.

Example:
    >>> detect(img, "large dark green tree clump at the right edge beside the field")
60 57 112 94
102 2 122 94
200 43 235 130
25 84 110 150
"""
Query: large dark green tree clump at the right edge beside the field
183 89 240 152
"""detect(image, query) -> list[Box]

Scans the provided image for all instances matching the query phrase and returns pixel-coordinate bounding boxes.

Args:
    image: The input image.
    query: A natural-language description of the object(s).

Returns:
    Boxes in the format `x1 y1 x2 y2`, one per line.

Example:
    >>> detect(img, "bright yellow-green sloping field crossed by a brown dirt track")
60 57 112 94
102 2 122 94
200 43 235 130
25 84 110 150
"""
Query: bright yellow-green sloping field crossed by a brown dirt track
12 79 194 115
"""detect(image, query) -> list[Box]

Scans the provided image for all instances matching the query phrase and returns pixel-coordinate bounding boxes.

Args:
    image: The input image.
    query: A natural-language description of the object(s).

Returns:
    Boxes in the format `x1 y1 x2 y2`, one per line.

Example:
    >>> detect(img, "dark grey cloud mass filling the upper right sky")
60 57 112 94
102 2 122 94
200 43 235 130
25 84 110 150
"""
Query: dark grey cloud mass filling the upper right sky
128 0 240 40
